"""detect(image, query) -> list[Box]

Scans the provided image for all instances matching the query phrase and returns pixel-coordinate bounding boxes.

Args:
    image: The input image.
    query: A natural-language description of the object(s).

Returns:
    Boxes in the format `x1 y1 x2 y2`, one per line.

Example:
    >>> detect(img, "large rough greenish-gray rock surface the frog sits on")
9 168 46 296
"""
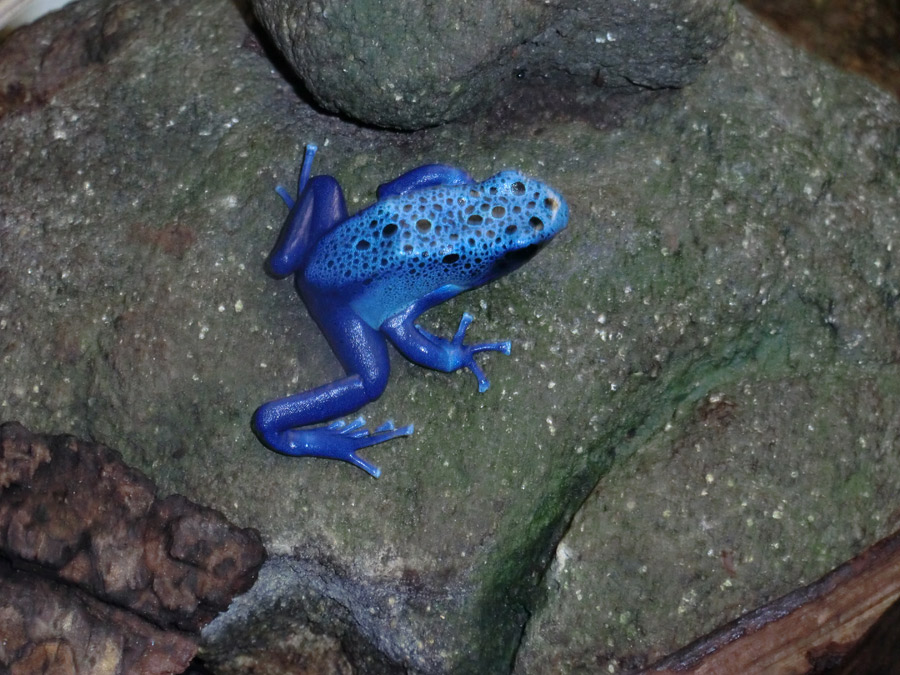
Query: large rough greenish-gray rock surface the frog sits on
0 0 900 673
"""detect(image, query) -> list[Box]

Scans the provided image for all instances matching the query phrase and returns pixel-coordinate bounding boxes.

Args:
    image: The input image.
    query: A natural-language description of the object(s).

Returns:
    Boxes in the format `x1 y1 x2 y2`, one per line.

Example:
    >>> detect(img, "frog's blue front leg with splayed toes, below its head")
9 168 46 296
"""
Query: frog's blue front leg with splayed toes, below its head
381 293 511 392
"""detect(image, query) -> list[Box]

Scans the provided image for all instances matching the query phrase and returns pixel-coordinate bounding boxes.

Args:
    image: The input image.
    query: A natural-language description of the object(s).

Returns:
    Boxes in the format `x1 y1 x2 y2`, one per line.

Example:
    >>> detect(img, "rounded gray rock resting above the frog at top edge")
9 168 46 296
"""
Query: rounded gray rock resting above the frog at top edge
254 0 730 129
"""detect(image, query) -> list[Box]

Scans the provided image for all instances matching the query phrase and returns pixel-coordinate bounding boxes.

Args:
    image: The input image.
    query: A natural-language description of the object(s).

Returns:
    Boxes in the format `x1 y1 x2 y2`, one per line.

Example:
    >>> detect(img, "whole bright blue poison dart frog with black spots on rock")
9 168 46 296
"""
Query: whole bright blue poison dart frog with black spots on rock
253 145 569 478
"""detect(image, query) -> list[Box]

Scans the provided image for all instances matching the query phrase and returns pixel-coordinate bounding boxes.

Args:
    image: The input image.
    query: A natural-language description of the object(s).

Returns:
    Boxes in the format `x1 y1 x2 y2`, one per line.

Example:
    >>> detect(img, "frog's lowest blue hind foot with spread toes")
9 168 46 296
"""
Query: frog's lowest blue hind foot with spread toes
269 417 413 478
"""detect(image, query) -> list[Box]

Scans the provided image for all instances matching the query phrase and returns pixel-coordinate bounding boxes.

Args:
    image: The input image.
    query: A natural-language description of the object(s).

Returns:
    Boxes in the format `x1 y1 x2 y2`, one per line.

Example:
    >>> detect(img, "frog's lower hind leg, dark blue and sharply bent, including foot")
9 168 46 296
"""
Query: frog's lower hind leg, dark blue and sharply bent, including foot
253 314 413 478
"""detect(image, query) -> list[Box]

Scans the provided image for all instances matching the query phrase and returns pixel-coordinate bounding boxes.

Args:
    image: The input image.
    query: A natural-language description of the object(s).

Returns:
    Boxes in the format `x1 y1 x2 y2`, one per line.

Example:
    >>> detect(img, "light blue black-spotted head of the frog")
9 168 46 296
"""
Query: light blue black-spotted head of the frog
466 171 569 285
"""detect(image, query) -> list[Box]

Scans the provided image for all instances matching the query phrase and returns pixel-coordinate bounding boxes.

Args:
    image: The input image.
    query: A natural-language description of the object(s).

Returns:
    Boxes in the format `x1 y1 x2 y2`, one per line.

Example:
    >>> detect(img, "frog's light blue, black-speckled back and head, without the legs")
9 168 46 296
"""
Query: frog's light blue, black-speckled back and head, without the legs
305 171 565 326
